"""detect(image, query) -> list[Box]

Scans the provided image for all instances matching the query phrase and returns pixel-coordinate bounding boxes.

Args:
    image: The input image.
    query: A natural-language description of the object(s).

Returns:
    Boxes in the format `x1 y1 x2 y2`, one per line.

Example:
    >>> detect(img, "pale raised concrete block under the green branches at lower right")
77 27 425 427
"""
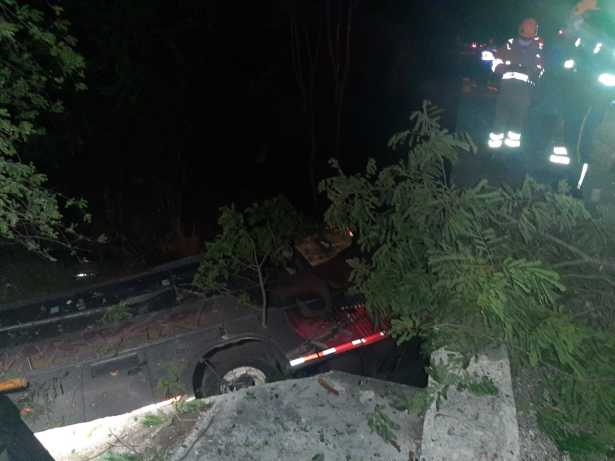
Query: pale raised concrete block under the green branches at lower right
421 349 520 461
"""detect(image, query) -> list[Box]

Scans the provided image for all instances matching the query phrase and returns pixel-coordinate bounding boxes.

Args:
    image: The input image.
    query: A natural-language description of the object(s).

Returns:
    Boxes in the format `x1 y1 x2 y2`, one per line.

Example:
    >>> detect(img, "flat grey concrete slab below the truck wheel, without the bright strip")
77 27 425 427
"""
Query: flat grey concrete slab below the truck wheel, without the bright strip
170 372 422 461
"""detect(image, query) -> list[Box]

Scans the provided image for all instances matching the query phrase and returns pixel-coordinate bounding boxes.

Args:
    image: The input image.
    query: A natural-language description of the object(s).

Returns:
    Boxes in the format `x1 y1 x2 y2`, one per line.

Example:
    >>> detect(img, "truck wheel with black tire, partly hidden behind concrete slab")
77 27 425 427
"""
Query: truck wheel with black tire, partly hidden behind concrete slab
200 343 280 397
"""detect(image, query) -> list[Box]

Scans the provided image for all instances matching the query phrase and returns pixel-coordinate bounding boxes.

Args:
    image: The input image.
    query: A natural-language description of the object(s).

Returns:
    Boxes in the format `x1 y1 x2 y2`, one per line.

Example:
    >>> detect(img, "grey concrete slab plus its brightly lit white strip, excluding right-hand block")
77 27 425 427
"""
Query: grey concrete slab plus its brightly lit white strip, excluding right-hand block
36 372 422 461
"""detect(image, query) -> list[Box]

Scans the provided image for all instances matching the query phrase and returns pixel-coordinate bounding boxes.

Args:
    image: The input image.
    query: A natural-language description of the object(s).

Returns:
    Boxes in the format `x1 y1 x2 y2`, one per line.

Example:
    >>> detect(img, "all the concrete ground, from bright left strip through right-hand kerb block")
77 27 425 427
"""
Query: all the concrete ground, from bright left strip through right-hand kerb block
37 360 566 461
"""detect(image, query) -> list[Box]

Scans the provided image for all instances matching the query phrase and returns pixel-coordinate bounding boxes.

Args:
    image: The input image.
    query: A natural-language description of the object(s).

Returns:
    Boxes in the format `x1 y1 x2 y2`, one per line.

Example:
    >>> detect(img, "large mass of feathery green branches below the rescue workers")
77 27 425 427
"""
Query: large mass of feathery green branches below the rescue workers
321 100 615 456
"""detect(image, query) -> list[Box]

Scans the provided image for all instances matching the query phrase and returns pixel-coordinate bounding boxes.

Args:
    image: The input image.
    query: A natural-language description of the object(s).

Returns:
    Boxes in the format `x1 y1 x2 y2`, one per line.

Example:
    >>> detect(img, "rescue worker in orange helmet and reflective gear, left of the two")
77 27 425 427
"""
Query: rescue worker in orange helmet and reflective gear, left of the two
488 18 544 149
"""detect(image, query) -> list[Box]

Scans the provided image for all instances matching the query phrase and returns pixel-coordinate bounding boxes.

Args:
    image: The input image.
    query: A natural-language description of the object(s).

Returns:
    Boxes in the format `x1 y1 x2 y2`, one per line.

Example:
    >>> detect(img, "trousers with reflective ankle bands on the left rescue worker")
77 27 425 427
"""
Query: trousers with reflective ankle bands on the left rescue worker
493 79 532 147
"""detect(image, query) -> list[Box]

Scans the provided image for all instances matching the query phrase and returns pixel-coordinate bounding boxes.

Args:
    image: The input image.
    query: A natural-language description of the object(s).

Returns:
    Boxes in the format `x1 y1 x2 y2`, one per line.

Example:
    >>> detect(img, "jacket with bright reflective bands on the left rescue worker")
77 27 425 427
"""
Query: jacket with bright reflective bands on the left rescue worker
491 37 544 84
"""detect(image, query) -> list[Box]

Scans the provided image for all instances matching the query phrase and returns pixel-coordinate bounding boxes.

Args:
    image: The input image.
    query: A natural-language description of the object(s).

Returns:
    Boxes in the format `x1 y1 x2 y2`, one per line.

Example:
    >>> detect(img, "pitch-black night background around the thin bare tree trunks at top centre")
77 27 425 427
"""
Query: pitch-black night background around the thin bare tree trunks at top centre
26 0 570 258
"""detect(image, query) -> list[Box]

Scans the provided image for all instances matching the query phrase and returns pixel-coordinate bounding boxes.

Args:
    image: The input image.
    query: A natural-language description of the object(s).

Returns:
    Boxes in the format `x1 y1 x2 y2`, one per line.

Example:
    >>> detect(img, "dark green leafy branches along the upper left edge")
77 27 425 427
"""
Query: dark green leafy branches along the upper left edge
0 0 89 256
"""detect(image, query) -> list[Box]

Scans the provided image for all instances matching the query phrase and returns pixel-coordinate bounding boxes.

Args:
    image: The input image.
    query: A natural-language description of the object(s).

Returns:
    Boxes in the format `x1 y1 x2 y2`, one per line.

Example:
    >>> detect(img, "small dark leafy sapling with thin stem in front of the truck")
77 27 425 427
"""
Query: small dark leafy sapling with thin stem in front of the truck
194 196 303 326
